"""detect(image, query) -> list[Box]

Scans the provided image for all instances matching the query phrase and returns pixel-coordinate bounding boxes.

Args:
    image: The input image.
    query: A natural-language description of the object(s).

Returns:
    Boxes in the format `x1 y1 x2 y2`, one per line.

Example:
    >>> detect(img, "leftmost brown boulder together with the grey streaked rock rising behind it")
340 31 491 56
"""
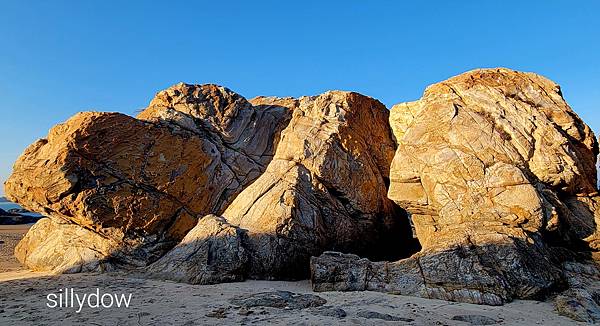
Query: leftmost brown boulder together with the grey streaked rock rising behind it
5 84 291 271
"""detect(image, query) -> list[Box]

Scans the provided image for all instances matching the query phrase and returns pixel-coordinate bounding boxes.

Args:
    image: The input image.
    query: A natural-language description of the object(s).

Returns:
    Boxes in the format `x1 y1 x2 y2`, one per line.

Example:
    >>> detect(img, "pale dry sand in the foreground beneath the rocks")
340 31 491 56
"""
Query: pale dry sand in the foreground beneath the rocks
0 226 576 325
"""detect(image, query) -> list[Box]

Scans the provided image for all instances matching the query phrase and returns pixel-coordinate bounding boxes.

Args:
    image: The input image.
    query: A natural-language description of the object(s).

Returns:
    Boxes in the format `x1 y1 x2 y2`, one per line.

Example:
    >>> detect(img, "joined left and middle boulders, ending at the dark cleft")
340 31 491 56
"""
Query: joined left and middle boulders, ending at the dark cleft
6 84 410 278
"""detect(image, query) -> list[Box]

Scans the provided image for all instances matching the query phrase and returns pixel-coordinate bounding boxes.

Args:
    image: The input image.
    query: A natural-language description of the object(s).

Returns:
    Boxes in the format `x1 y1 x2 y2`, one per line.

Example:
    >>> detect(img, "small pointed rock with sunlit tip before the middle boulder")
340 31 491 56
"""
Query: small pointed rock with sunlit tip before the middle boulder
146 215 248 284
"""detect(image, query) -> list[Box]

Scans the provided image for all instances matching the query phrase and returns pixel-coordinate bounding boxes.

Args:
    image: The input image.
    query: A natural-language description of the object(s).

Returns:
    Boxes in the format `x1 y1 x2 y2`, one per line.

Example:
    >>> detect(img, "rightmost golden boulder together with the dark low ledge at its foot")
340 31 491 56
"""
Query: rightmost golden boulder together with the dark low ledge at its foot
312 69 600 304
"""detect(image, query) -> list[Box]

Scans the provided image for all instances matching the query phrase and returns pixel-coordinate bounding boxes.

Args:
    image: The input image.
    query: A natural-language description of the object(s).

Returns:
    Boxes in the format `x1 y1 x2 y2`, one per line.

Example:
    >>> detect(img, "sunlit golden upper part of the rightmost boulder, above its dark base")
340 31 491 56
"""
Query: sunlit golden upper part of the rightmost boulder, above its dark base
389 69 598 249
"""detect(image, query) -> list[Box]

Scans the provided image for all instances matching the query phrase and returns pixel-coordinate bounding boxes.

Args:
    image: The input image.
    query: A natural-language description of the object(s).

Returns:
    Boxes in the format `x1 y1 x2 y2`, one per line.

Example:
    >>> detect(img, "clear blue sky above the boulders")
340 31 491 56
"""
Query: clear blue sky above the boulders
0 0 600 194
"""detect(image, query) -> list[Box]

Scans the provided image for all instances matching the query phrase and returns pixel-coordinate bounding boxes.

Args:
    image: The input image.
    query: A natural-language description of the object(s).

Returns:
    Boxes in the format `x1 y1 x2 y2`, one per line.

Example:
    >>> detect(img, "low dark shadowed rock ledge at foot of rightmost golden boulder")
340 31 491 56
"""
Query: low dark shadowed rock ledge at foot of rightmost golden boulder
311 241 565 305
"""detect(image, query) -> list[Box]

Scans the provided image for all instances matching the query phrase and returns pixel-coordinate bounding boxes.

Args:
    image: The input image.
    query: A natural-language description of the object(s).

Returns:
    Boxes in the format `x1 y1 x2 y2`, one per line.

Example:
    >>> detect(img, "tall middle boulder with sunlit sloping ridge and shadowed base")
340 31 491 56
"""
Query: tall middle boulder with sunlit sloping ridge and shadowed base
148 91 413 280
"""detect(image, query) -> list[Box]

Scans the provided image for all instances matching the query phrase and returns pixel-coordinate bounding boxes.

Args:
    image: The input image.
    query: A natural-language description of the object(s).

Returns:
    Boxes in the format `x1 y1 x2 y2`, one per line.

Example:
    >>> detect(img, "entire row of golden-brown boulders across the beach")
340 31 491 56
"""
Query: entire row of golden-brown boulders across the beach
6 69 600 310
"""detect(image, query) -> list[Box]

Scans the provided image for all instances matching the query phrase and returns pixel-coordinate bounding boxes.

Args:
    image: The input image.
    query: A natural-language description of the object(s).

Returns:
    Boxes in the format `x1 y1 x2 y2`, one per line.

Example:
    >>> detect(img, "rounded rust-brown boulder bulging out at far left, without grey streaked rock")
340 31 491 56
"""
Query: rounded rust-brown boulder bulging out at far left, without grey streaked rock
5 112 207 272
